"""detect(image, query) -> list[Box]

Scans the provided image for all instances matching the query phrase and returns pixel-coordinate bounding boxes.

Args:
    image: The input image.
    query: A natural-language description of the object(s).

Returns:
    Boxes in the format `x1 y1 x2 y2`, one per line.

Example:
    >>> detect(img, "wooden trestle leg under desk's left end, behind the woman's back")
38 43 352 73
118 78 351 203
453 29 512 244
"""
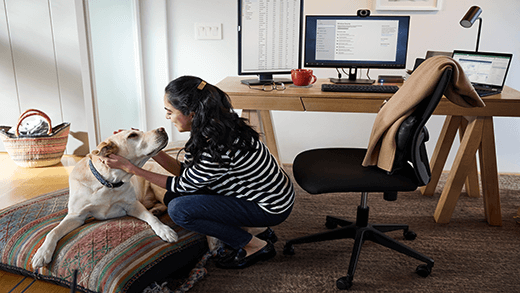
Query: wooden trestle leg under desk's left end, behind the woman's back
242 110 281 164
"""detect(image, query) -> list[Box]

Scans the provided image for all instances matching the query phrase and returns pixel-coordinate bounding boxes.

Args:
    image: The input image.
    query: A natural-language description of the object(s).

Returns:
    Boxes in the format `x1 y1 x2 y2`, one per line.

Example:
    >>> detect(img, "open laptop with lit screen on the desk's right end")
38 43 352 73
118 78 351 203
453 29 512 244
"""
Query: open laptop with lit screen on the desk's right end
452 50 513 97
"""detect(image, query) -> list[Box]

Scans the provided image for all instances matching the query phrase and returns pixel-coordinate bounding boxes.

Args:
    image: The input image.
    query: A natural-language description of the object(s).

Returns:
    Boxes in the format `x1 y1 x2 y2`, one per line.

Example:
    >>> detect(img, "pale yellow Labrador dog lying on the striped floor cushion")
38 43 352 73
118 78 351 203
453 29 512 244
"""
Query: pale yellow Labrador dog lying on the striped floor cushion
32 128 178 269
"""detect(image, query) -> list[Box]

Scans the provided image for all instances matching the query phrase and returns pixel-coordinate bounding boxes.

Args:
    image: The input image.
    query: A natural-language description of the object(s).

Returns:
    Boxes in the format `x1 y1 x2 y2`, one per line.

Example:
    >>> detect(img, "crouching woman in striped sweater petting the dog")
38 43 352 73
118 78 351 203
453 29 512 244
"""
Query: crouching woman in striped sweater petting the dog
105 76 294 268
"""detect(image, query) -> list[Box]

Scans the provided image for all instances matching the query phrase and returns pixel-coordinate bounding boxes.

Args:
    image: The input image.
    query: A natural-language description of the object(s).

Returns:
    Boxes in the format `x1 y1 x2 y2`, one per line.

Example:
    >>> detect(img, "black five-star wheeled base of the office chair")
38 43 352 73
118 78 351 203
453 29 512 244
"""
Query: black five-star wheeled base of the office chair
283 206 434 289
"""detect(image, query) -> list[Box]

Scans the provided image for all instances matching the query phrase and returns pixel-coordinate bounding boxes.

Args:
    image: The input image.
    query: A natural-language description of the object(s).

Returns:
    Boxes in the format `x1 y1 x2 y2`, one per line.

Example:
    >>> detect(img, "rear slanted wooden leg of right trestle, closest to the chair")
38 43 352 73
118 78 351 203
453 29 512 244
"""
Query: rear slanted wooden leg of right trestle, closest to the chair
420 116 462 196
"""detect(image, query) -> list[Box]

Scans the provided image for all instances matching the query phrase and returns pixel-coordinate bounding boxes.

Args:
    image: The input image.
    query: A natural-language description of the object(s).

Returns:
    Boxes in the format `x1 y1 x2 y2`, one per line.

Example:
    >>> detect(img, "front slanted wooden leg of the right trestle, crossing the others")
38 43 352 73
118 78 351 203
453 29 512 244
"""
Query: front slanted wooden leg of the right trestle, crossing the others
433 117 484 223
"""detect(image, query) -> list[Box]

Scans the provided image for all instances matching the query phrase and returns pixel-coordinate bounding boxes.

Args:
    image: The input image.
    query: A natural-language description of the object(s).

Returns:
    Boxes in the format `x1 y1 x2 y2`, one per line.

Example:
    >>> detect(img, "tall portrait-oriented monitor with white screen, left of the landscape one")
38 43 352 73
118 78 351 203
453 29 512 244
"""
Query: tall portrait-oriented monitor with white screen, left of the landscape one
238 0 303 85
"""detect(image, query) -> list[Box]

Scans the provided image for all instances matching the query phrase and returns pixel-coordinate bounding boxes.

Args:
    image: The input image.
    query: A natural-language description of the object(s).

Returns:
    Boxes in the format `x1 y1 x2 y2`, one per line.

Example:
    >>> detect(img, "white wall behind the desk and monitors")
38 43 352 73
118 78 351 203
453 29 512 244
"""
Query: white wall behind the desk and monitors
168 0 520 173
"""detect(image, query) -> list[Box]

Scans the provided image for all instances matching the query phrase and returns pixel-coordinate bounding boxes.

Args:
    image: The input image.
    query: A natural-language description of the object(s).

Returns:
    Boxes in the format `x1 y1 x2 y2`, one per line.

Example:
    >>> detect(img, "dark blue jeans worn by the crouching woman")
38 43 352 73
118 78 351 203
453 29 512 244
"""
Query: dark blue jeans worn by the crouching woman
168 194 292 249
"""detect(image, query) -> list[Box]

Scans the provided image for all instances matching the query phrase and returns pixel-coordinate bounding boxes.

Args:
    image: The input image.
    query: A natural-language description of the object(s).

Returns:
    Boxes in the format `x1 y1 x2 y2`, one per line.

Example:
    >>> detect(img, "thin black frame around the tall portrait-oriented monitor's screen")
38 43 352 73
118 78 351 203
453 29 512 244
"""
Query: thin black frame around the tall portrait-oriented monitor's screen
237 0 304 79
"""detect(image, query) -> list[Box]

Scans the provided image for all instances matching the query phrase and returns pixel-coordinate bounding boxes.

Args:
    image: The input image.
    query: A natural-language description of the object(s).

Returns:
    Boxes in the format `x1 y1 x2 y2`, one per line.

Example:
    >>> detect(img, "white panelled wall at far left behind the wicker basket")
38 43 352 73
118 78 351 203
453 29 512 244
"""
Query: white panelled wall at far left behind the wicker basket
0 0 89 154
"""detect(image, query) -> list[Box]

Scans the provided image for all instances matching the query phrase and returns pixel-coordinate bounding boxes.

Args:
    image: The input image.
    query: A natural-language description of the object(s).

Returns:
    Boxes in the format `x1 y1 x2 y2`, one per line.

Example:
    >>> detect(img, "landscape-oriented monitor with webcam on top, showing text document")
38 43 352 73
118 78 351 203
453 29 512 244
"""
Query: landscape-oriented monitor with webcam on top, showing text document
304 15 410 83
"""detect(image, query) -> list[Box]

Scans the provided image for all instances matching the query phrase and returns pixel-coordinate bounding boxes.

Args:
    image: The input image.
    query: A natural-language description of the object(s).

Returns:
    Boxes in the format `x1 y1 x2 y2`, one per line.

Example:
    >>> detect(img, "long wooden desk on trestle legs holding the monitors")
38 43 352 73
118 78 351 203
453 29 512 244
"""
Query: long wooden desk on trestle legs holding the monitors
217 77 520 226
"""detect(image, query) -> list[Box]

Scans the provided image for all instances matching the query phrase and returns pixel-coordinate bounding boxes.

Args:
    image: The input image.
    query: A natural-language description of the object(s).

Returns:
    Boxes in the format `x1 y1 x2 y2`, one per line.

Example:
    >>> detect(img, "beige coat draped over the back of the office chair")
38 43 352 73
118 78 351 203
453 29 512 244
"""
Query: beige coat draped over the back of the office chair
363 56 485 171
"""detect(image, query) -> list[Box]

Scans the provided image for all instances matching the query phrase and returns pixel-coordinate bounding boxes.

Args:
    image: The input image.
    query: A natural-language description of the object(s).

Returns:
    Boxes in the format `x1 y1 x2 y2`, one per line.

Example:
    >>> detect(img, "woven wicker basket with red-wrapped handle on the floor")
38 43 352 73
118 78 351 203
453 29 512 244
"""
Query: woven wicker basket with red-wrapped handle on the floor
0 109 70 167
